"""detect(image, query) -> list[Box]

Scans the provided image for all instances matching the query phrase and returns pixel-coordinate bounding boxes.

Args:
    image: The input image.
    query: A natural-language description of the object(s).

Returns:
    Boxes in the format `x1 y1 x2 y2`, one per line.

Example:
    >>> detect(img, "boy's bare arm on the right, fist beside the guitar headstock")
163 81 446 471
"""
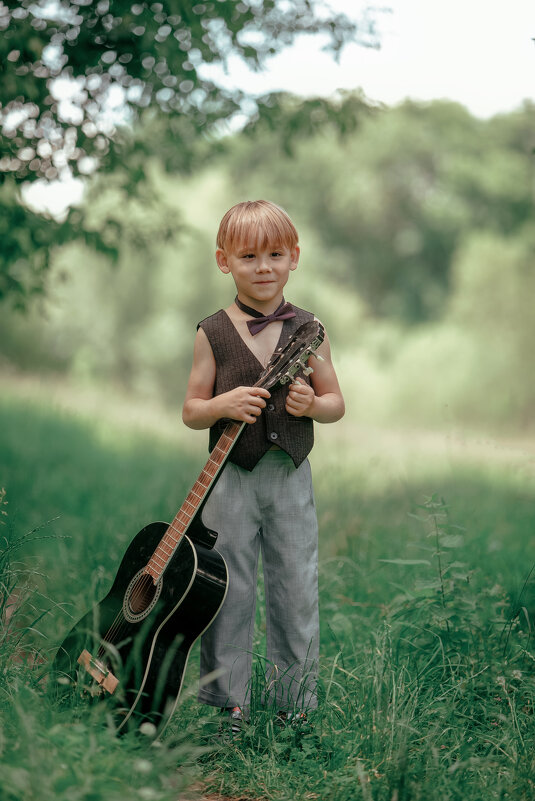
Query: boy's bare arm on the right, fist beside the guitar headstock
286 326 345 423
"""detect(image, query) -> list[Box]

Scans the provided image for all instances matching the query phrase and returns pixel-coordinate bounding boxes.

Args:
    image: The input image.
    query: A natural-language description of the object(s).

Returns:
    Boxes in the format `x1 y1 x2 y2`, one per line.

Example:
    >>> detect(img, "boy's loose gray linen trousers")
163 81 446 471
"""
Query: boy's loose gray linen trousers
199 450 319 711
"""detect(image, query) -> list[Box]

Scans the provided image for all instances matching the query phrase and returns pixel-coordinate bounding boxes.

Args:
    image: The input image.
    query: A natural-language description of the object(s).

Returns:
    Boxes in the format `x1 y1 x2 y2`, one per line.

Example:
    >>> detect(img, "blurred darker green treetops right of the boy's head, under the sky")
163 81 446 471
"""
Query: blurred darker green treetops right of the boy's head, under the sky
229 99 535 324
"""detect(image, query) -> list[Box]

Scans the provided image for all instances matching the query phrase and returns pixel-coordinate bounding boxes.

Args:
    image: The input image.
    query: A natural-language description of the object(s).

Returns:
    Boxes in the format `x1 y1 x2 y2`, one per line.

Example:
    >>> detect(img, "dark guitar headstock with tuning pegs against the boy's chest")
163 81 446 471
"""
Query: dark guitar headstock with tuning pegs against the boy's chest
255 320 325 389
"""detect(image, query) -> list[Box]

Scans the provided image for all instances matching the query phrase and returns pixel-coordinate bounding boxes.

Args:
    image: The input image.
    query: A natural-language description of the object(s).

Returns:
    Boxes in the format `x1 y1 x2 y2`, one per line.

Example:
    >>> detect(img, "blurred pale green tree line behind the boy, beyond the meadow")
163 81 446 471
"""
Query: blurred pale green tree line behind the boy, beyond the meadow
0 103 535 430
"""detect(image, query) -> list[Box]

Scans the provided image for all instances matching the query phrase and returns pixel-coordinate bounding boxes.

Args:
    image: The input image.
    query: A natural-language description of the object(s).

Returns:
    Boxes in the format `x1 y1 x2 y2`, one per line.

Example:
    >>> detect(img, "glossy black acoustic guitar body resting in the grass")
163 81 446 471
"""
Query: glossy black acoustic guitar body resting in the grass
52 523 227 733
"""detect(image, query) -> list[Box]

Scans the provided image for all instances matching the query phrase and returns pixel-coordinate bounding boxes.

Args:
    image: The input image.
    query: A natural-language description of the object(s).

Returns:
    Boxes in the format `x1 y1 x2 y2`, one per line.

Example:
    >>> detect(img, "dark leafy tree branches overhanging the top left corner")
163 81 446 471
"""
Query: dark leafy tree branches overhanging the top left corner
0 0 374 299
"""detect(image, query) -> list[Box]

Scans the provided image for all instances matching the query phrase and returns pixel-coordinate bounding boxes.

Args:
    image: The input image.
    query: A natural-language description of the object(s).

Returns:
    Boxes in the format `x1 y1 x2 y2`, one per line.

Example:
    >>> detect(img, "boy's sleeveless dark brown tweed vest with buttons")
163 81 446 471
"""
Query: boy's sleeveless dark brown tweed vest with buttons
199 306 314 470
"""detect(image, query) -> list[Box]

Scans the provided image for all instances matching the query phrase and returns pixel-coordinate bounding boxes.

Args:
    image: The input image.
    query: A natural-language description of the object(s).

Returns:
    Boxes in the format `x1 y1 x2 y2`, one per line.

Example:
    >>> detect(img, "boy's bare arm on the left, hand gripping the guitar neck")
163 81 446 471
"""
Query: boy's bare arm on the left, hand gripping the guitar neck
182 328 270 429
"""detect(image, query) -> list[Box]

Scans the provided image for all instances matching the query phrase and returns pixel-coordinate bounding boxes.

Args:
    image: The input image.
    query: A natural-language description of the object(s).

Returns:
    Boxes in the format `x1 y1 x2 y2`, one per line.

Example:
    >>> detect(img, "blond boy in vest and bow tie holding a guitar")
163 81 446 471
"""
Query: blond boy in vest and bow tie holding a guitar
183 200 344 732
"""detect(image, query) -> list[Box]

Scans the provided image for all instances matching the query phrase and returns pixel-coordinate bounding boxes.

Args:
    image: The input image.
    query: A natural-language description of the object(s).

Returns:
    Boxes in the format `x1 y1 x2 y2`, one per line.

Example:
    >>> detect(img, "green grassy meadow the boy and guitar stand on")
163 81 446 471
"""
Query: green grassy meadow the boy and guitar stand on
0 380 535 801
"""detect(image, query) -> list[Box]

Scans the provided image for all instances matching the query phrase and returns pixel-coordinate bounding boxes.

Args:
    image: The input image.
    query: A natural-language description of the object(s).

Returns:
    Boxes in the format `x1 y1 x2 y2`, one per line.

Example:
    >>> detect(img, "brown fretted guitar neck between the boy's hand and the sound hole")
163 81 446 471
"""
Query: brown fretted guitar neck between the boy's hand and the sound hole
145 423 246 582
